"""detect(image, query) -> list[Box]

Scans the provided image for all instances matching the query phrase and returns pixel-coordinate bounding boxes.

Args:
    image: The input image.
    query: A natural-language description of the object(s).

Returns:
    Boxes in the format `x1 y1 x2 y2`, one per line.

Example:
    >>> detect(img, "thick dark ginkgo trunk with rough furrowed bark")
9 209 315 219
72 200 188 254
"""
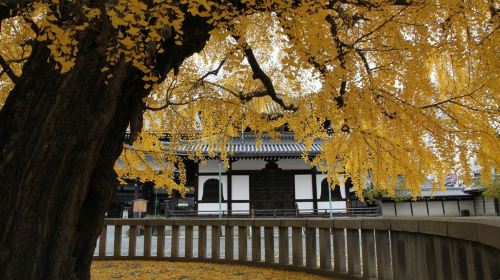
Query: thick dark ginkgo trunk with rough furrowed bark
0 15 209 280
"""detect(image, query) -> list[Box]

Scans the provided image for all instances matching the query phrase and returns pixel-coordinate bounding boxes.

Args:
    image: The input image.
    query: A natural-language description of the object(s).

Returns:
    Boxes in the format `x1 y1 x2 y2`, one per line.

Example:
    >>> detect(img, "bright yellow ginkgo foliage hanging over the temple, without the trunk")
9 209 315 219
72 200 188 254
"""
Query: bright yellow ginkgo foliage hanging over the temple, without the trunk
0 0 500 199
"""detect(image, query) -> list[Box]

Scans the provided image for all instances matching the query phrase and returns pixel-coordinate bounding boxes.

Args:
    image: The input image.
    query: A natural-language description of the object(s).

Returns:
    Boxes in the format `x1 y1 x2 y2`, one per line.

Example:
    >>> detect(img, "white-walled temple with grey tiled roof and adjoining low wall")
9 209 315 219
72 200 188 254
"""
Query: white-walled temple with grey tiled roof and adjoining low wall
108 132 499 217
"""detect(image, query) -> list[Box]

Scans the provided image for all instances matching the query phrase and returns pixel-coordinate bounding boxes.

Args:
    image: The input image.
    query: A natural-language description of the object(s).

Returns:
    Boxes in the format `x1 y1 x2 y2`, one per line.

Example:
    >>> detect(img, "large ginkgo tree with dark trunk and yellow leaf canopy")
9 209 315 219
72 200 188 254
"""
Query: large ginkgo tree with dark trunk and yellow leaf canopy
0 0 500 279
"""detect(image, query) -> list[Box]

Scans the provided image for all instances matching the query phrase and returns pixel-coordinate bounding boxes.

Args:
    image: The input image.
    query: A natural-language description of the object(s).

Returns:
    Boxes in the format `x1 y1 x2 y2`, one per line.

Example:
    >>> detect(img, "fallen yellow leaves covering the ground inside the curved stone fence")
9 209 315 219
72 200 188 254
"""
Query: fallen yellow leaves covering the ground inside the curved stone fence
91 261 330 280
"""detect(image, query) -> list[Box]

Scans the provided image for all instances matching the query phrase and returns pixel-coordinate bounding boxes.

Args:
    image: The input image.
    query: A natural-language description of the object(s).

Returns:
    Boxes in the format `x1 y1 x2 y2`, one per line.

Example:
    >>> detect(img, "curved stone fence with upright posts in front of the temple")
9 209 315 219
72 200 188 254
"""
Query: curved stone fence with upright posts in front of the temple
95 218 500 279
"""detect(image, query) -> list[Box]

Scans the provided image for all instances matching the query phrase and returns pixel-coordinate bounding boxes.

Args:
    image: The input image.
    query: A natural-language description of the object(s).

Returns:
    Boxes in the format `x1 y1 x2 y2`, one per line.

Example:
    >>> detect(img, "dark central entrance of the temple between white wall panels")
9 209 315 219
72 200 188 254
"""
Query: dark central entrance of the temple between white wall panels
250 163 295 210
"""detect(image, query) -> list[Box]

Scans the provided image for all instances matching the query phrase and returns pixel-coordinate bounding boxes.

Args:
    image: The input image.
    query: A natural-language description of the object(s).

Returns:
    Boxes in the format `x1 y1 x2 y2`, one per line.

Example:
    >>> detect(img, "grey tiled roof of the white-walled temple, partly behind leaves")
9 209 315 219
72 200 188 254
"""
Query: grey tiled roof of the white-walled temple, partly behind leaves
165 133 321 157
